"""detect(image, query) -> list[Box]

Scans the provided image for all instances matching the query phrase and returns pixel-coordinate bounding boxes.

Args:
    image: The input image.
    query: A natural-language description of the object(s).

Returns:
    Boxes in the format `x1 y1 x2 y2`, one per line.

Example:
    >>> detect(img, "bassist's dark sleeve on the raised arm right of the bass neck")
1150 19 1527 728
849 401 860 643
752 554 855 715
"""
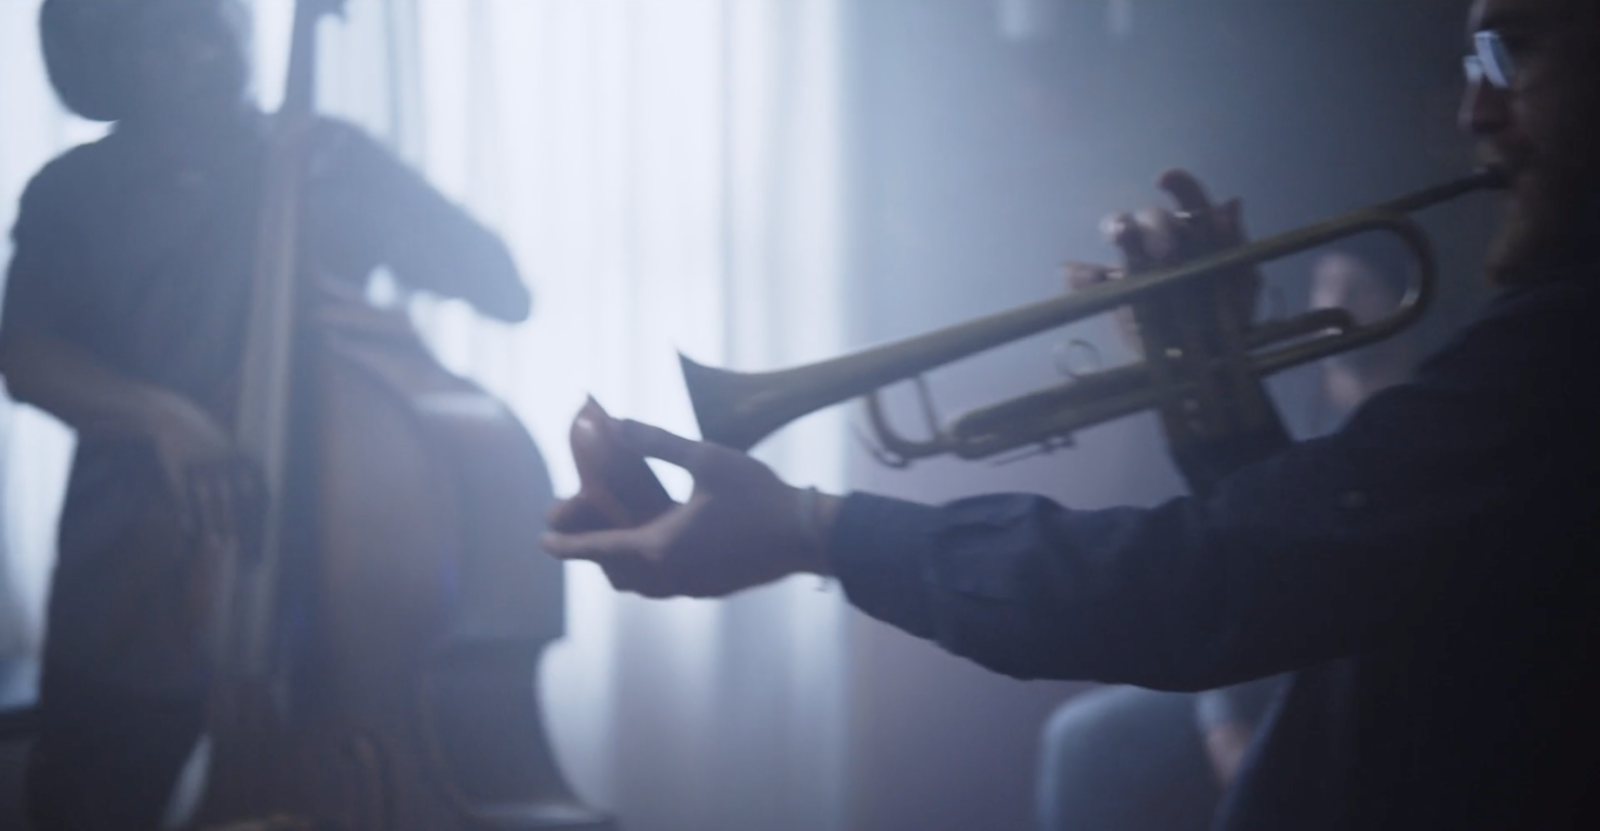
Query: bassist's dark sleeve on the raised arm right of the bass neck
297 120 530 320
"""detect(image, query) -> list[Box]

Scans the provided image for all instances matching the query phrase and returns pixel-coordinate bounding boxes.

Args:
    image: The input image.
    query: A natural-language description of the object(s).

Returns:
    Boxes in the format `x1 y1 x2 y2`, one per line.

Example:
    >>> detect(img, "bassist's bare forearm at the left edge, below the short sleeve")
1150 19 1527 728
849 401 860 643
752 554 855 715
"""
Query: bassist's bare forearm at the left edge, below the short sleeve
0 331 176 439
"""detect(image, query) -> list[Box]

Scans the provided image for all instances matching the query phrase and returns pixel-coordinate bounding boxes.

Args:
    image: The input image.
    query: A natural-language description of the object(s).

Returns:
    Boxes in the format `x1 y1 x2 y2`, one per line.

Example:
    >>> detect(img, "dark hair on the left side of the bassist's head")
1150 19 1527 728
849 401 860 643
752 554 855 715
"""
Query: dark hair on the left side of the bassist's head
38 0 149 122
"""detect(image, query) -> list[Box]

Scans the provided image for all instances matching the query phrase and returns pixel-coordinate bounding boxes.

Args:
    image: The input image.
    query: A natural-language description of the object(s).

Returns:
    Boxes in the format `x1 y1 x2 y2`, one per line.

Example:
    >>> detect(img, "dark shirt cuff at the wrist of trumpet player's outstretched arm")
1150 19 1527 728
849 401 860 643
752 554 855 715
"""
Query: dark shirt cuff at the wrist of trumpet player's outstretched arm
827 493 939 637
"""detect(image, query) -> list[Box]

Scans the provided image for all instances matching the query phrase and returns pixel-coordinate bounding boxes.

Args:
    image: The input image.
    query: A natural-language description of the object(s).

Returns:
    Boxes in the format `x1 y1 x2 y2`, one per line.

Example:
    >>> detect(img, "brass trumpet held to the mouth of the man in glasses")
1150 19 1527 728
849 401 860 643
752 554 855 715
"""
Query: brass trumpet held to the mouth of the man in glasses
680 166 1502 460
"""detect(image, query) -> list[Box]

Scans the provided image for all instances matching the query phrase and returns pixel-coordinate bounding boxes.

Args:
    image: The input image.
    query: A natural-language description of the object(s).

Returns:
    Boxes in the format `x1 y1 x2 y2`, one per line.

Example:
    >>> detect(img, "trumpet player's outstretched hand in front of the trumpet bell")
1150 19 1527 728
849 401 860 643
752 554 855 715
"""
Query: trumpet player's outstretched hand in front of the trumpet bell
544 407 838 597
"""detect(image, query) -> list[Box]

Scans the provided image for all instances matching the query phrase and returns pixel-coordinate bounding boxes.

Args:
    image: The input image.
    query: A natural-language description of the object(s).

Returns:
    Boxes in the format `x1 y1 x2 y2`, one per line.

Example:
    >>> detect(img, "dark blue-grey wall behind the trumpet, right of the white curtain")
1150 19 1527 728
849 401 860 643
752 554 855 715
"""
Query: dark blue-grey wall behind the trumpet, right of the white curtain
848 0 1493 831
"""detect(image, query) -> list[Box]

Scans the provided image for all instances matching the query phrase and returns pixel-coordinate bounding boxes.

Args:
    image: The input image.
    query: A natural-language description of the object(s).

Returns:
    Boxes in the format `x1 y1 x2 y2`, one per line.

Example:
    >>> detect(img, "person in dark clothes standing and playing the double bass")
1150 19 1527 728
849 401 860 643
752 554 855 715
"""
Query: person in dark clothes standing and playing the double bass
0 0 530 831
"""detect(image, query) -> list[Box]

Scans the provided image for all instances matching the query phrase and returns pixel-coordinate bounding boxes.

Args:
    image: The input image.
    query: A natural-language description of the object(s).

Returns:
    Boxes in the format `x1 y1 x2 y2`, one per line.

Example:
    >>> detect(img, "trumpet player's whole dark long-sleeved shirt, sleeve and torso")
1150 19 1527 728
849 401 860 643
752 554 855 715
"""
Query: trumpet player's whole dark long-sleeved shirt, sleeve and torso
832 269 1600 831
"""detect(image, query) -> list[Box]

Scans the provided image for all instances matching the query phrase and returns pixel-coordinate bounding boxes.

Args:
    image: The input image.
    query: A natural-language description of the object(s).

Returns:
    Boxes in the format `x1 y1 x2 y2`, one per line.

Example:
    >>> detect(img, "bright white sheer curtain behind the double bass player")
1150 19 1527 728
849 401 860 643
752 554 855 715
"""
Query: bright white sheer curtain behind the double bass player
0 0 846 831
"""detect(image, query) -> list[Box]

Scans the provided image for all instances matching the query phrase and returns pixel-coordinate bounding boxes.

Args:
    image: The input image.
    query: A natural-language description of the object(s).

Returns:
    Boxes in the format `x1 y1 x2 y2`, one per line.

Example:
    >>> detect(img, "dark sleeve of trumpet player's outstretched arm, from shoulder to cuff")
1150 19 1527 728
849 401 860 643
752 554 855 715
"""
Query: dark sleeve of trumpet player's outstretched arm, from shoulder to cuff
830 280 1600 690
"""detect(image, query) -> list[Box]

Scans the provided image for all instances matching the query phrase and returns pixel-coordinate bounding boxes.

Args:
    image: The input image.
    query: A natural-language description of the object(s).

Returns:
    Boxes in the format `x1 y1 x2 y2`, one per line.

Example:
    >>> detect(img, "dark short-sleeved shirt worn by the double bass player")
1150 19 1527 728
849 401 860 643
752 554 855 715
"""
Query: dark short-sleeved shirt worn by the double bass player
0 110 526 693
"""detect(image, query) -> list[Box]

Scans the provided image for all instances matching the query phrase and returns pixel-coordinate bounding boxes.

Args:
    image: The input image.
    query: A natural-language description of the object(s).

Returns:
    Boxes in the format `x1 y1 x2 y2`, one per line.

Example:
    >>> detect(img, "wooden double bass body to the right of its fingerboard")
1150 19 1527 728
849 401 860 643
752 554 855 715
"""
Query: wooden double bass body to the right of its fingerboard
294 296 610 831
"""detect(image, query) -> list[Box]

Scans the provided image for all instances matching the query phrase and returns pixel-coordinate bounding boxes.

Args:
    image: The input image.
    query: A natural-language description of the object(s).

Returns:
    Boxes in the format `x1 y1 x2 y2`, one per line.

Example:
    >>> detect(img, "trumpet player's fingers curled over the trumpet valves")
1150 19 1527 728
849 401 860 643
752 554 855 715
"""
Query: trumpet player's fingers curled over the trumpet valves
1064 170 1261 354
